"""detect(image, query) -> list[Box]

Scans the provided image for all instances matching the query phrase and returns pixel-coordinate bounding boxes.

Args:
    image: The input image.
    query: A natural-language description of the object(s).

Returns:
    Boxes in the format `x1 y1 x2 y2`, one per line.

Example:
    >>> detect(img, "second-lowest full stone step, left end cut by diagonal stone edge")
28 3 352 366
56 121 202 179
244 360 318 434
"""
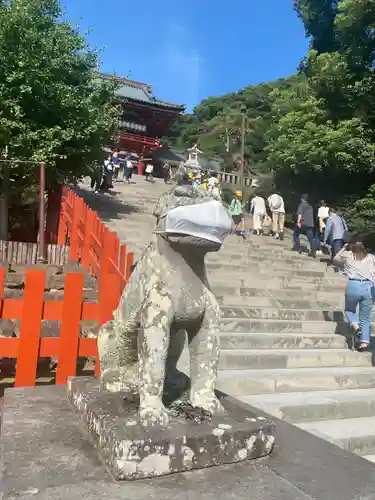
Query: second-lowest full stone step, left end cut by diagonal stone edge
241 389 375 423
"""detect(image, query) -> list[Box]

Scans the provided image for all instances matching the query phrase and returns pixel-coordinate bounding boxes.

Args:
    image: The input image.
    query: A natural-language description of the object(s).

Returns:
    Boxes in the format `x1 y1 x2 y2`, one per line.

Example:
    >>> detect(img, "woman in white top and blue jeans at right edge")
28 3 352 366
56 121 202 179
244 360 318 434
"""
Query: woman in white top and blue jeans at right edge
335 237 375 352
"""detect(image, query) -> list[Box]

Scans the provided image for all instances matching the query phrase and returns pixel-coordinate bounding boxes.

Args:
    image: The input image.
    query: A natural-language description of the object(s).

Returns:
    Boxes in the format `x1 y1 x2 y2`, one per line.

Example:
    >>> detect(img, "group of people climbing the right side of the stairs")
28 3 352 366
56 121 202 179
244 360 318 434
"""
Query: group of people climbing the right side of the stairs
239 192 375 352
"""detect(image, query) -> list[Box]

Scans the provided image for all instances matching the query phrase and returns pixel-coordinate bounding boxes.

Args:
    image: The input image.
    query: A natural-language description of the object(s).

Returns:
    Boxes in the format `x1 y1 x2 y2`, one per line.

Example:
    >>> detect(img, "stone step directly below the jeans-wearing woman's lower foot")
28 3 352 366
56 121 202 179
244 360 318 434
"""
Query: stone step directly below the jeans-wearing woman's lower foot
219 348 375 376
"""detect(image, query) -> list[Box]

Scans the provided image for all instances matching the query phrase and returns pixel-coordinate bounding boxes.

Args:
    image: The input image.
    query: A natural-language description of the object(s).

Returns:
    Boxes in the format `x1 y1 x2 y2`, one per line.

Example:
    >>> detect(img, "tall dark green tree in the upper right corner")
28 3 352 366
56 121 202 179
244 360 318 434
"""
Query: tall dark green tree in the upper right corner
267 0 375 212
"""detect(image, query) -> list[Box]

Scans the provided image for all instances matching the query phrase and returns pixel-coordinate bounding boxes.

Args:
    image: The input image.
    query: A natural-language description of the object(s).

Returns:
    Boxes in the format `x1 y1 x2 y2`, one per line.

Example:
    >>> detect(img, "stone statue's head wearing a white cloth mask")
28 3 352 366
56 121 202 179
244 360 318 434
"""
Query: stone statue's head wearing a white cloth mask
154 184 233 251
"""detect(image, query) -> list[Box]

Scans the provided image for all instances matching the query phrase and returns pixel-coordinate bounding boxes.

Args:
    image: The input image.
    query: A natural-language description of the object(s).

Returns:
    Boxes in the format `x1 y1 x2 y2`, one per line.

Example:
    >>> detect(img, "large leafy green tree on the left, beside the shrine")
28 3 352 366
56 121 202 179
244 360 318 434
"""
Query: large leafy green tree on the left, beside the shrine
0 0 117 237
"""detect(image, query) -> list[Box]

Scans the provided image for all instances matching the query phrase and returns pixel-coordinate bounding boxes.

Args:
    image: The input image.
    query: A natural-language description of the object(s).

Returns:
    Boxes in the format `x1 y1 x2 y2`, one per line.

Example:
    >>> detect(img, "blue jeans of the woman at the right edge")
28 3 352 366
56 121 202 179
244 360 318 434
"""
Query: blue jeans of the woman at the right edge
345 280 374 344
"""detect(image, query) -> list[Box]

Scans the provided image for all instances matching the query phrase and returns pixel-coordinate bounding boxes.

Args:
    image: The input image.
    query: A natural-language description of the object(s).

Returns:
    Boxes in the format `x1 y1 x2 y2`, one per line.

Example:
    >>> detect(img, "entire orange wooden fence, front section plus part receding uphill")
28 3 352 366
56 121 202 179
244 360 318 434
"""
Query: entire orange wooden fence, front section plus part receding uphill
0 187 134 387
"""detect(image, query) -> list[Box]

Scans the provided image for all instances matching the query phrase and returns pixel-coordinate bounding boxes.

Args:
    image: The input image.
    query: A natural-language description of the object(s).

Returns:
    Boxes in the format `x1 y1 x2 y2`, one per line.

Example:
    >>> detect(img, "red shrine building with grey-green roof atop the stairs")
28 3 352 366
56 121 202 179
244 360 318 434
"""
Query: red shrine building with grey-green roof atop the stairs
101 74 185 163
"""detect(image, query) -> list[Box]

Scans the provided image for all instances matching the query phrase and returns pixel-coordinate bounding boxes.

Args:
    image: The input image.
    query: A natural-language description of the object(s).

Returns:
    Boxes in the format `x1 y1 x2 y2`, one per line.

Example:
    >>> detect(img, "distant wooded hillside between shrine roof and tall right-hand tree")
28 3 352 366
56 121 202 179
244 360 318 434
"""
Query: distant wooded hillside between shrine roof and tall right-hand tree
165 75 305 172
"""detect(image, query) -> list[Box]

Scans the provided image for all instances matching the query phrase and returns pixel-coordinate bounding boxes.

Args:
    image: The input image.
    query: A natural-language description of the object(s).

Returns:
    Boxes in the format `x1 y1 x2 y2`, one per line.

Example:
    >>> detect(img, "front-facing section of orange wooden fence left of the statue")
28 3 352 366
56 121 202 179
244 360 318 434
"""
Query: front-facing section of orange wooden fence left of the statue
0 268 120 387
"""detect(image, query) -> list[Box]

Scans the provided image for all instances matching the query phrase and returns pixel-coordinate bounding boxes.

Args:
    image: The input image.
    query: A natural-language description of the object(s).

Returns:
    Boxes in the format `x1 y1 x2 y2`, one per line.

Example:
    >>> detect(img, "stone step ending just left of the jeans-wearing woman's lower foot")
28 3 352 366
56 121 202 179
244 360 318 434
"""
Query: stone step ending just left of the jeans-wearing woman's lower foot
220 332 350 351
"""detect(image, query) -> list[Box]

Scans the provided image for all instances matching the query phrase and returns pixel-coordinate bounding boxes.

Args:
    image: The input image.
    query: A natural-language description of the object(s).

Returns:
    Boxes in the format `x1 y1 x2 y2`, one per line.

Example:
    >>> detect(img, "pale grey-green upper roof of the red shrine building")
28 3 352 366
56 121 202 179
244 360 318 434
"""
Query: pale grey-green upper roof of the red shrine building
101 73 185 112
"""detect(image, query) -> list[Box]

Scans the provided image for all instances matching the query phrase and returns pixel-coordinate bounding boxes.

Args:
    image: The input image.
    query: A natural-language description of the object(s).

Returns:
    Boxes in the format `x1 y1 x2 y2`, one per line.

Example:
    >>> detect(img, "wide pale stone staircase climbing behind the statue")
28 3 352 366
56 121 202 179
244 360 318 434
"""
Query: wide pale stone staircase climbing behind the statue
78 177 375 461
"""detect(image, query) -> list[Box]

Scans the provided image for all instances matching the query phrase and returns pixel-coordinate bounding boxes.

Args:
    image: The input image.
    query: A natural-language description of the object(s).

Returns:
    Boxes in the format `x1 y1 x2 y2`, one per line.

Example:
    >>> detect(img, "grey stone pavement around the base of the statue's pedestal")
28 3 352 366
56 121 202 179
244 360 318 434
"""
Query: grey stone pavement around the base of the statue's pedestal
0 386 375 500
